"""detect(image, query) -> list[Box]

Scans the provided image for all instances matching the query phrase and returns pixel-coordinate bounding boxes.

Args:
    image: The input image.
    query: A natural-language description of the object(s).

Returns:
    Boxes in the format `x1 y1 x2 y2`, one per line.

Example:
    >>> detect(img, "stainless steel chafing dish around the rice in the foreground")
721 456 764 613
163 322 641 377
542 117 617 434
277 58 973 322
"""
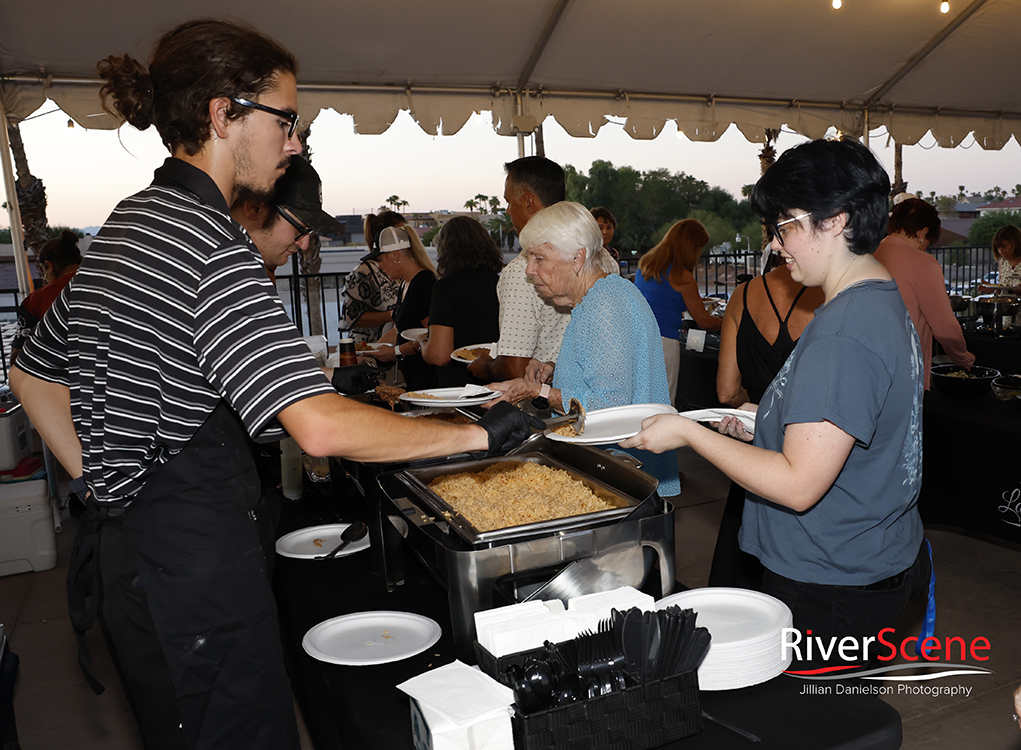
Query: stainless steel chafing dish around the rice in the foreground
379 439 674 661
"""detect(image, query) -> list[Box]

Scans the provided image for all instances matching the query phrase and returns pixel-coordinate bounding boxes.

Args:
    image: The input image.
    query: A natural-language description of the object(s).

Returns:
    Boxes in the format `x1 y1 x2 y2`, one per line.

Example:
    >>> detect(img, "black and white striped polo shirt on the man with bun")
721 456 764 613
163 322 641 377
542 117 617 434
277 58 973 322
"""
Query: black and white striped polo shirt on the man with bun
17 158 334 508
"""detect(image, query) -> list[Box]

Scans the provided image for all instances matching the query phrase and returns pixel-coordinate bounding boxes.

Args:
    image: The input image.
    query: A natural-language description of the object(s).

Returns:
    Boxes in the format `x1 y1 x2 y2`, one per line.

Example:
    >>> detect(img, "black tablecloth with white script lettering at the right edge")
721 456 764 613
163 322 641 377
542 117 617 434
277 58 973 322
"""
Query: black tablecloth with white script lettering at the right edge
919 389 1021 543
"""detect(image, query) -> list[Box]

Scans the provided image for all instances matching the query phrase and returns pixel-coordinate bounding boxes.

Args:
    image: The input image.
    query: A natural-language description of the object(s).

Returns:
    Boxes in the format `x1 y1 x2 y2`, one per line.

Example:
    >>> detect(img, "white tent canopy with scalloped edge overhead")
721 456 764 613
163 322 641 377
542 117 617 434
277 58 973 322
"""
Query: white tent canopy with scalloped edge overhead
0 0 1021 148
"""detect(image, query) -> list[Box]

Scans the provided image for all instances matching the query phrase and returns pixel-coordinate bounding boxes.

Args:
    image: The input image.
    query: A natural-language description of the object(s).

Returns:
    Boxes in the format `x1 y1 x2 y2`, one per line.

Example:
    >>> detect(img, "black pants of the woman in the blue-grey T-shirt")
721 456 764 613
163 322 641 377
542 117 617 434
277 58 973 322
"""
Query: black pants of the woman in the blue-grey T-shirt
762 542 931 668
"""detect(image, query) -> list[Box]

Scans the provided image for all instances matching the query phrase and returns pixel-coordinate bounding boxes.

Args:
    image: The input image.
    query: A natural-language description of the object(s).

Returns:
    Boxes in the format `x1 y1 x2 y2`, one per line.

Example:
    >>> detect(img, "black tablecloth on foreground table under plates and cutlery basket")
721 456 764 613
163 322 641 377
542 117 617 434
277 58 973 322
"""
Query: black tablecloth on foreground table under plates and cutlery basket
275 493 901 750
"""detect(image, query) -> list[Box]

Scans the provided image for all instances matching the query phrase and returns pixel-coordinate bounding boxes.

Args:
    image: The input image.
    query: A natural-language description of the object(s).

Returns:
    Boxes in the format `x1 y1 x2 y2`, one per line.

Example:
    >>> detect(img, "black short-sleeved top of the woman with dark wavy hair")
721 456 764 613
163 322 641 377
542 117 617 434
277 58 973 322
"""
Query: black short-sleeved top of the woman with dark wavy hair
429 268 500 388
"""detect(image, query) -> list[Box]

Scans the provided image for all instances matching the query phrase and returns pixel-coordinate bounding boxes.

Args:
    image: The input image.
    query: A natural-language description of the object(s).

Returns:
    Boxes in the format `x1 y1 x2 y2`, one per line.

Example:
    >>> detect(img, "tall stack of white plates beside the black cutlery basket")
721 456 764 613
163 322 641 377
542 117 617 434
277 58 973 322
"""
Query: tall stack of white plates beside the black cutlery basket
655 589 793 690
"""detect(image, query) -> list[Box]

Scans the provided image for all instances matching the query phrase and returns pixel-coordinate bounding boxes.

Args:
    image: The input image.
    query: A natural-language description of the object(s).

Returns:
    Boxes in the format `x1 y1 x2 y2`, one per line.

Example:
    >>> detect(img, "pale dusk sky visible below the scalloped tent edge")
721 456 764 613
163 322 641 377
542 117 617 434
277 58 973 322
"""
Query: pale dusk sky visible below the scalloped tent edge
0 102 1021 233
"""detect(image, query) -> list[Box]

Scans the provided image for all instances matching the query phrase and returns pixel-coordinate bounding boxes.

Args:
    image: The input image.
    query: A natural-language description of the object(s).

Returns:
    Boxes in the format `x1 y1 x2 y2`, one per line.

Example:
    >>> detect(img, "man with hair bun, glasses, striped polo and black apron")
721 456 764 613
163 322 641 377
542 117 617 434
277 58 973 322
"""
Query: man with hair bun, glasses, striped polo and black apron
10 18 529 750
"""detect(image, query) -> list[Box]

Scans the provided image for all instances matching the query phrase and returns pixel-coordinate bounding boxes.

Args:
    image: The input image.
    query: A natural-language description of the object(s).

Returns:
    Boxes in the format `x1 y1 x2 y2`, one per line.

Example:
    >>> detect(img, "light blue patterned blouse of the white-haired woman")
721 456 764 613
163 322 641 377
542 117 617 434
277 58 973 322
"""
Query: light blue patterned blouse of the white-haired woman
552 276 681 497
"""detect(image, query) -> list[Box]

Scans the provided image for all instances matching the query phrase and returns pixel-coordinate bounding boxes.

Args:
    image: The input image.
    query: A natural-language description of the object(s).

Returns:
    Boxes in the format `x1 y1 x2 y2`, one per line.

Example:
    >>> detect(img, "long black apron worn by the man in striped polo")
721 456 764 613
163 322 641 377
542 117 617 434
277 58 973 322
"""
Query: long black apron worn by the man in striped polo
68 402 298 750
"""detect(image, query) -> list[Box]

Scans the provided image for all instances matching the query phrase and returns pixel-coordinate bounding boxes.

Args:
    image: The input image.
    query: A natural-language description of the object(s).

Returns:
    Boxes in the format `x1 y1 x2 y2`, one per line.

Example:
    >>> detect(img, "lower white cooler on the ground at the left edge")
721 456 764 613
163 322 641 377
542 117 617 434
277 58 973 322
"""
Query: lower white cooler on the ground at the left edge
0 480 57 576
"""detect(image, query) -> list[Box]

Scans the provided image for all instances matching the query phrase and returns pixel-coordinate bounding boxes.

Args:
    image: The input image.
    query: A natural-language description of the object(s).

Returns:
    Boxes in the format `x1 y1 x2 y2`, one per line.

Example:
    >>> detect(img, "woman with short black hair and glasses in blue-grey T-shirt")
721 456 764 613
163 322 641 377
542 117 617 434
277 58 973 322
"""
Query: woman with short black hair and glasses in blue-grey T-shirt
622 141 929 669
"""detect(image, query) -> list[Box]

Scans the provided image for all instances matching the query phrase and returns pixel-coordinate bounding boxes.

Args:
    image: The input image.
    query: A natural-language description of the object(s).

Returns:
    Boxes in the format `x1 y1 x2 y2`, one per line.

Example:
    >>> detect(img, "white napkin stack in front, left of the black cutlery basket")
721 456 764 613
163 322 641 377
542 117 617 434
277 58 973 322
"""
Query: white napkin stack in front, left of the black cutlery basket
397 661 514 750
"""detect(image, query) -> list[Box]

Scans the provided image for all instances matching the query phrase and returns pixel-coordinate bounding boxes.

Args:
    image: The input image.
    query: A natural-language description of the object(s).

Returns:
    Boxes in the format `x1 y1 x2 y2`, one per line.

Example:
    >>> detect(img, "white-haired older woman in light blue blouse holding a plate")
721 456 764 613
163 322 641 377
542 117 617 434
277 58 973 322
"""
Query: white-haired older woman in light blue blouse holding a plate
491 201 681 497
